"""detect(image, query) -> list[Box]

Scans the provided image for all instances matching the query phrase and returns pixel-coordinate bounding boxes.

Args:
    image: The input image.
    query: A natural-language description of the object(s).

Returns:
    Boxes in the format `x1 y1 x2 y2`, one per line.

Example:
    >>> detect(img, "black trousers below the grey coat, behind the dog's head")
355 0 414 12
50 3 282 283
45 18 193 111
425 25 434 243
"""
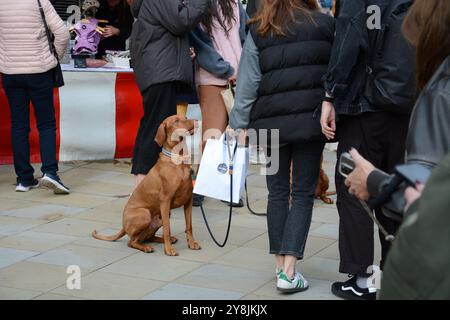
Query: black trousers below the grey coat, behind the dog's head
131 82 179 174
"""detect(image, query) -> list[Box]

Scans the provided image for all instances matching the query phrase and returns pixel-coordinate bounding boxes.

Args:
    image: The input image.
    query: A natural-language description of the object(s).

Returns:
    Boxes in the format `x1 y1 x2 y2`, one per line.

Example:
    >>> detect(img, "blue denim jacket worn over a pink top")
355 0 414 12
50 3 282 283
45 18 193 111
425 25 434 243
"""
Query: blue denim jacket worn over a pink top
189 1 248 79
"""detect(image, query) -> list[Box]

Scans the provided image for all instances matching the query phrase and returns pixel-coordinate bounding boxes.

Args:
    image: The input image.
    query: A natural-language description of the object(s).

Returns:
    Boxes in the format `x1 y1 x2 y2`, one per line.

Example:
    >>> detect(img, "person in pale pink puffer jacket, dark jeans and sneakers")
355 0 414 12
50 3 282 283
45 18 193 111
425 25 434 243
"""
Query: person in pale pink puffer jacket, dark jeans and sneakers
0 0 70 194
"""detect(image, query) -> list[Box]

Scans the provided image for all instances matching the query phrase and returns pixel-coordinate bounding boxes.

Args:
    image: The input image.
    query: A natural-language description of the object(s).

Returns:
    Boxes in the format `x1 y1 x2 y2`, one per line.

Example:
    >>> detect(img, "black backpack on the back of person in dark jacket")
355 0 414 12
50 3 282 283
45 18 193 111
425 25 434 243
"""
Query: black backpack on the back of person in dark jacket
364 0 416 114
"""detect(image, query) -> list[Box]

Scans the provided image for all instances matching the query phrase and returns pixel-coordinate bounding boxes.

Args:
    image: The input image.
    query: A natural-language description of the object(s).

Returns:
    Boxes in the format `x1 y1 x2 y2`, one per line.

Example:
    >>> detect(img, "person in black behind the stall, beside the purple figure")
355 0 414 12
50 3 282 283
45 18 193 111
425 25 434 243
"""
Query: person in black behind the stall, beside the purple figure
96 0 134 58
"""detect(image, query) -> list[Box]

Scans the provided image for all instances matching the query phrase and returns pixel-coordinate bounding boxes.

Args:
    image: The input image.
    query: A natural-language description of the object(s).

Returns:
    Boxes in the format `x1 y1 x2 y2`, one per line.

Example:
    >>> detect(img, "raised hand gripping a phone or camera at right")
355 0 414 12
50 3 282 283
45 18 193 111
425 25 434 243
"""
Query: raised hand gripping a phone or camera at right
345 149 375 201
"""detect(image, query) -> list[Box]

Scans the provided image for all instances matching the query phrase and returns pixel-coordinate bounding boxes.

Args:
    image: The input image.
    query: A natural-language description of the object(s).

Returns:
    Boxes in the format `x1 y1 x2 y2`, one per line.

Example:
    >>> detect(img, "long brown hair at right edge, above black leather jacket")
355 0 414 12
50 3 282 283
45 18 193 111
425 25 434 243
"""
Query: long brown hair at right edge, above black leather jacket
403 0 450 90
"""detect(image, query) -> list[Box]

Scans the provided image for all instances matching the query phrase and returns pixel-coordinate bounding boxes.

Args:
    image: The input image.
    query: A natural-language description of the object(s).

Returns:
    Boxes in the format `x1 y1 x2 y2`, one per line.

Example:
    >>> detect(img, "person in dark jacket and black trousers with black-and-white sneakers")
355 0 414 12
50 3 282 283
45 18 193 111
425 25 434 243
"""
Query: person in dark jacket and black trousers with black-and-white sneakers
321 0 415 300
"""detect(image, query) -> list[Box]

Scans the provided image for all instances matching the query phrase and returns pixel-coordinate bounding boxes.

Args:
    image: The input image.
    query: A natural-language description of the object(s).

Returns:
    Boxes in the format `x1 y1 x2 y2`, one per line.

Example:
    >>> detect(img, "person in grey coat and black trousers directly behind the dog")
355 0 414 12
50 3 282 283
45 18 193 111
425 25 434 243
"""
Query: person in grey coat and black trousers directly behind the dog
131 0 210 186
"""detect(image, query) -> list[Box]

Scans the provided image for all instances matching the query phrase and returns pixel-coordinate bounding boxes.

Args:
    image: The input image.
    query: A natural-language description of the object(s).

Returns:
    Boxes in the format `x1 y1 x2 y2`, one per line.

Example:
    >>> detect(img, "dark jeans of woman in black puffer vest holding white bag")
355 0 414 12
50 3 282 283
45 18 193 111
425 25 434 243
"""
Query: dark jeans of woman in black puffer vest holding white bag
266 142 324 259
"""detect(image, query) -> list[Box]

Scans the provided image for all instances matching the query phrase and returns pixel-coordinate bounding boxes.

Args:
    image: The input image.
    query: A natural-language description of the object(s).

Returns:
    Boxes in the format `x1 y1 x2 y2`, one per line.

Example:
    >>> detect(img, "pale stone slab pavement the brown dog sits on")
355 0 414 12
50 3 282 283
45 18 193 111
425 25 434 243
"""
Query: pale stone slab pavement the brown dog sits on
0 151 379 300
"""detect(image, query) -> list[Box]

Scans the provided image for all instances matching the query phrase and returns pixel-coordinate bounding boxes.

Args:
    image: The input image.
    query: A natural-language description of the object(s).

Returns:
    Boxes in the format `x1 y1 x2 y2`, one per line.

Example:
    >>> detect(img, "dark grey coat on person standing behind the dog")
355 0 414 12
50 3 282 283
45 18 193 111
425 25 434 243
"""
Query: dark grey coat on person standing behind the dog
131 0 211 92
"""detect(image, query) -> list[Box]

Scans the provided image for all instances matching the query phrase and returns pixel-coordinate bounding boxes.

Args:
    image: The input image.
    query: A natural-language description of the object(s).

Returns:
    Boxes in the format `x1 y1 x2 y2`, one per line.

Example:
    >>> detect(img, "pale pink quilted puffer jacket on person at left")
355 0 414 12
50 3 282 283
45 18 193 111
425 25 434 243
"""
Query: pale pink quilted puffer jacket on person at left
0 0 70 74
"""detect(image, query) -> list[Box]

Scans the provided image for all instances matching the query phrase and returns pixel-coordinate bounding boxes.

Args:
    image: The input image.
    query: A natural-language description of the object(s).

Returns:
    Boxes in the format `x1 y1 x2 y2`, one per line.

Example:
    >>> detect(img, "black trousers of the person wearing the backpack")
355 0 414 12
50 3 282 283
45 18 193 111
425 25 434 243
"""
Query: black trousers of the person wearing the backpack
335 112 409 276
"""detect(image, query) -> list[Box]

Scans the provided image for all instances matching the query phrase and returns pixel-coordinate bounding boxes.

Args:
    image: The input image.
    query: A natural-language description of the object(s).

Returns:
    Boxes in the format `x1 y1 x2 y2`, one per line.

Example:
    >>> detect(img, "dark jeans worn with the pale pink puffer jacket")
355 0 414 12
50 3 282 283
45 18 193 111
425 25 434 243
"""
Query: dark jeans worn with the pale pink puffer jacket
2 70 58 184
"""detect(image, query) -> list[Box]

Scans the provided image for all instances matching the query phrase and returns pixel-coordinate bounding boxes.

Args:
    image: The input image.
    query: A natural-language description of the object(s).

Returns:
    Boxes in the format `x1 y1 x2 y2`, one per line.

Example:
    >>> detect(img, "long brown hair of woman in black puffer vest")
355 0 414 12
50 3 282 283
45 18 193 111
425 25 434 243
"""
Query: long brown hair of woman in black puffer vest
249 0 320 36
